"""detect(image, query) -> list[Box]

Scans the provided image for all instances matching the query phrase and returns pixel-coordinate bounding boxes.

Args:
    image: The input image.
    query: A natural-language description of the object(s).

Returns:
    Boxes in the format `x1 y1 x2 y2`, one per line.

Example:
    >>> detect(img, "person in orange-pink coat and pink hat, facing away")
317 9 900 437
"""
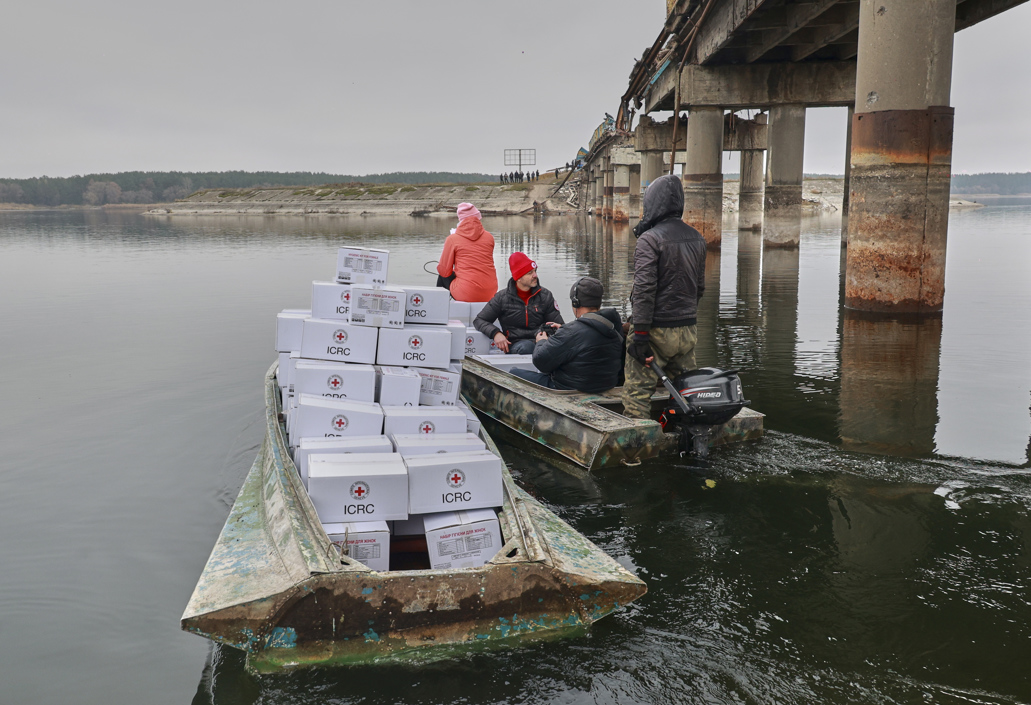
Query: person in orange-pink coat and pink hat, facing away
437 203 498 302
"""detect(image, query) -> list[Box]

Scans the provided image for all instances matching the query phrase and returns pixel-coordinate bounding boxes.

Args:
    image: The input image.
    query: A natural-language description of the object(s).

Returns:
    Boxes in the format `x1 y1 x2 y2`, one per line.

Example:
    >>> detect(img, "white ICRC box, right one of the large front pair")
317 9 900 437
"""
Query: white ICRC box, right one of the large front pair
404 451 504 514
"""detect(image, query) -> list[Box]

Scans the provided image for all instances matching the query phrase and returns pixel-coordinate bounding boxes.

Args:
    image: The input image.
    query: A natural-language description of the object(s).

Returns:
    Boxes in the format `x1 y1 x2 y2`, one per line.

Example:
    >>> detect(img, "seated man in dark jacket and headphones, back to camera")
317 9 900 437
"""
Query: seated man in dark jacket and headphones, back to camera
511 276 623 394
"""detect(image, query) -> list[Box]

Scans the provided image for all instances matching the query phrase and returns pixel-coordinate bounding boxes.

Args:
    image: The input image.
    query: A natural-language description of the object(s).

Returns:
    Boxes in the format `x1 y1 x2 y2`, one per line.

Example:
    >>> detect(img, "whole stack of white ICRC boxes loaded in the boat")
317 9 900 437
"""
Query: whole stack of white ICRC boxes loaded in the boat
276 247 503 570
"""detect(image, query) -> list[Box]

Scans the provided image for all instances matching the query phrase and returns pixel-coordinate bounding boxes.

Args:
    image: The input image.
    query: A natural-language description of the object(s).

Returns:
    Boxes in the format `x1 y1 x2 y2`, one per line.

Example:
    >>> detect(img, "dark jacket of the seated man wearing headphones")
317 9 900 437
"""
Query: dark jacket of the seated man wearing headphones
533 308 623 393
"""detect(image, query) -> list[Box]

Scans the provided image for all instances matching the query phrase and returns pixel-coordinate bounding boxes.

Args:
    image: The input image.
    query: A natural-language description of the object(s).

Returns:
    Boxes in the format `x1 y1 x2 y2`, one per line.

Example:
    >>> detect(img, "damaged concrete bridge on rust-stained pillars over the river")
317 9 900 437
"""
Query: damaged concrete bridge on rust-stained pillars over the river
580 0 1026 313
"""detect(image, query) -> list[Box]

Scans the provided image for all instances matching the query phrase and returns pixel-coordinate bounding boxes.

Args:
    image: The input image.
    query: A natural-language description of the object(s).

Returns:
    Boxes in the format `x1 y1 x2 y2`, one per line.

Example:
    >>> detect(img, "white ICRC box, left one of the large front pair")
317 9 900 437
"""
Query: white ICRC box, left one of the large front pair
308 452 408 524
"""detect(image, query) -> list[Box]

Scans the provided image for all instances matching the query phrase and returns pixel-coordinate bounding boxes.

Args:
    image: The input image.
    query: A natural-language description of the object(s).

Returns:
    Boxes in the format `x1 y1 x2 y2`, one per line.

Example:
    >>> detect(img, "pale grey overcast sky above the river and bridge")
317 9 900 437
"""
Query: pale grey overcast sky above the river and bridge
0 0 1031 177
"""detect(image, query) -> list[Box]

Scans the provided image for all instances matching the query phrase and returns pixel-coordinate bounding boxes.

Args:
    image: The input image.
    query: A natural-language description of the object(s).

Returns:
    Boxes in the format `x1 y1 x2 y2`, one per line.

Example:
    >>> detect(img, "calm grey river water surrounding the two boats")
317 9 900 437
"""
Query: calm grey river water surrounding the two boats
0 205 1031 705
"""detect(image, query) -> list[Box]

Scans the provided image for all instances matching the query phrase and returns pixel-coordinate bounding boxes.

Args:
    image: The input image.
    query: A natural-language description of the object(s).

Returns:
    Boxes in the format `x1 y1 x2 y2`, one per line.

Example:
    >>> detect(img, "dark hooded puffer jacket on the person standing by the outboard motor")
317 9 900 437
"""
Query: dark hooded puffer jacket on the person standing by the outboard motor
632 174 705 331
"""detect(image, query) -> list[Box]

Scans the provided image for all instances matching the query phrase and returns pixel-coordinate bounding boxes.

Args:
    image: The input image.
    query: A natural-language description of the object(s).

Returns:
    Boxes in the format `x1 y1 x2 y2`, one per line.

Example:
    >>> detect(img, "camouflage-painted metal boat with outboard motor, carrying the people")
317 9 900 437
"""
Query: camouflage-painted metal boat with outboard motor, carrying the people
462 356 764 470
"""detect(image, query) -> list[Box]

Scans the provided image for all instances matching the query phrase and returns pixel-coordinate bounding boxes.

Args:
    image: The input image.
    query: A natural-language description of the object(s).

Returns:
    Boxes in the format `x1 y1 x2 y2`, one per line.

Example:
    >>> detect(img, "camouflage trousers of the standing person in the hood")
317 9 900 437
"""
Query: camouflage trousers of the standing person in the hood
623 326 698 418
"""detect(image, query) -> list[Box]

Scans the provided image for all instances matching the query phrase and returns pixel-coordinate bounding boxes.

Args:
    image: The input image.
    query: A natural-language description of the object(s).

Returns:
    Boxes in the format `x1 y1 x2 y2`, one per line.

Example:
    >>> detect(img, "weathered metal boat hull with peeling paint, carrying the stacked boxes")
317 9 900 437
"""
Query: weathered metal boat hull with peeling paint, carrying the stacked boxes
181 365 646 672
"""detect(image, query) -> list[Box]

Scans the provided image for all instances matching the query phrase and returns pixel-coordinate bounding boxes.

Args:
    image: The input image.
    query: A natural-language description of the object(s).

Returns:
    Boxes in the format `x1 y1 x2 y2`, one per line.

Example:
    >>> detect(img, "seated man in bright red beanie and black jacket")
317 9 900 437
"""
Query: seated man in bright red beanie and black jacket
472 253 563 355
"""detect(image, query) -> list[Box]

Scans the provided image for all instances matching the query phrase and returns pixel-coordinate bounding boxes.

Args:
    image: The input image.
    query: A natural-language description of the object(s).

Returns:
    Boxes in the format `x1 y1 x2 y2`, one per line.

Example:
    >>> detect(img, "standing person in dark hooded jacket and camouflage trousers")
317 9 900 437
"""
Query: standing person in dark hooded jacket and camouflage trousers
623 174 705 418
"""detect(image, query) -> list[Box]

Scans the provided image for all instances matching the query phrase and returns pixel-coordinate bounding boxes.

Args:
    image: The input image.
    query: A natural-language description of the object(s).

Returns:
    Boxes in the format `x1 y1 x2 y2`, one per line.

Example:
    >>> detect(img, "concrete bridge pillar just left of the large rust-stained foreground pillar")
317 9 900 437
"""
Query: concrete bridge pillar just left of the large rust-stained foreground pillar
763 105 805 247
